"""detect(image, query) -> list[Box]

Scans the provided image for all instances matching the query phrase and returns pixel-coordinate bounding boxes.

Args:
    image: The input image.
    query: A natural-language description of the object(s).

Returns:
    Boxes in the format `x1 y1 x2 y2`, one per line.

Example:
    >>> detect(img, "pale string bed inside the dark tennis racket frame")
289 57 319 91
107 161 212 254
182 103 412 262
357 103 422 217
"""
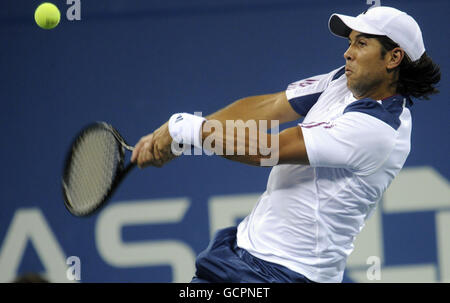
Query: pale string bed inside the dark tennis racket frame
65 129 121 213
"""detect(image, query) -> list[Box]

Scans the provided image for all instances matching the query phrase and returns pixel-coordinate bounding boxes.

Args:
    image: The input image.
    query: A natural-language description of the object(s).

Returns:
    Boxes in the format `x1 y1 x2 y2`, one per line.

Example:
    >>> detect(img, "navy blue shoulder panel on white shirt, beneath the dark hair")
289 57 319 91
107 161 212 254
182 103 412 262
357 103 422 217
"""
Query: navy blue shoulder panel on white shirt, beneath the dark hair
344 95 412 130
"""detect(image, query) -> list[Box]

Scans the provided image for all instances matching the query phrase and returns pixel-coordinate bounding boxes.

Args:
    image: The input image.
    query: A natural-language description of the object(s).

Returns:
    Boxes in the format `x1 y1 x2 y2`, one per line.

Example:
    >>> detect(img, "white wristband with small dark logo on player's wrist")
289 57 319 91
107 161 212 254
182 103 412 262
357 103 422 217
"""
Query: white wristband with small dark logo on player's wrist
169 113 206 148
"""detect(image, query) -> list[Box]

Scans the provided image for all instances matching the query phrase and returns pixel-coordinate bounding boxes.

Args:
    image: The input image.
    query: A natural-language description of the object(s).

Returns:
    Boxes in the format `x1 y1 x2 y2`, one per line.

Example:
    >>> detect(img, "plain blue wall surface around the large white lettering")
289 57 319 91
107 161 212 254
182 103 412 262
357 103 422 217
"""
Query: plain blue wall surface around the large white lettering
0 0 450 282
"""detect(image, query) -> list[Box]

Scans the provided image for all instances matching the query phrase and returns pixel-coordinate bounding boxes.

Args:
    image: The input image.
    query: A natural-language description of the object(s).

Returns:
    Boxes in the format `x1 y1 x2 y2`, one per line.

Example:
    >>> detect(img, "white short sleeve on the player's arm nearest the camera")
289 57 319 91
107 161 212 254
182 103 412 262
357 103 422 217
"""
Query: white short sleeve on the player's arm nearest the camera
300 112 396 175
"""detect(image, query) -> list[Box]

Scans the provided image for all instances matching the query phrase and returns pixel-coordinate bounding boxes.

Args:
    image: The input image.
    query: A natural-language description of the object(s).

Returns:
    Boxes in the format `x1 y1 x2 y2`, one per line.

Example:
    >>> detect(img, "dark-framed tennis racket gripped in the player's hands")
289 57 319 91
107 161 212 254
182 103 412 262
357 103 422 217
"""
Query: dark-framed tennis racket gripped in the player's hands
62 122 136 216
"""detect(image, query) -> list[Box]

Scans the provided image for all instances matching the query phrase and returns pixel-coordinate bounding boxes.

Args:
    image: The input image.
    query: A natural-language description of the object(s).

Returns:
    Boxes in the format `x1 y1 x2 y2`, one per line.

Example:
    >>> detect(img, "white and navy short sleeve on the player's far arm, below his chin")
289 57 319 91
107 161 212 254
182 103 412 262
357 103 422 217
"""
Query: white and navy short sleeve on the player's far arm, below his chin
286 67 345 116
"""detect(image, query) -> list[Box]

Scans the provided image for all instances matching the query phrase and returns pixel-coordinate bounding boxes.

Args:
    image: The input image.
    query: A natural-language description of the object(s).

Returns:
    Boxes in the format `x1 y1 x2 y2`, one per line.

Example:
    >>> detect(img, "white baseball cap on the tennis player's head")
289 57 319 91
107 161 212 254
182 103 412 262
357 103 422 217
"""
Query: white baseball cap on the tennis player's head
328 6 425 61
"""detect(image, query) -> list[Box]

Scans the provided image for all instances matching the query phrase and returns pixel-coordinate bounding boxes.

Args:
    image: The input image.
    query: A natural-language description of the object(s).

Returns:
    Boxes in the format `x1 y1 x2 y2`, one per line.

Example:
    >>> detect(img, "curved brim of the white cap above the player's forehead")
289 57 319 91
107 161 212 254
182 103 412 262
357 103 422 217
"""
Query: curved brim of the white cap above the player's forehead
328 14 385 38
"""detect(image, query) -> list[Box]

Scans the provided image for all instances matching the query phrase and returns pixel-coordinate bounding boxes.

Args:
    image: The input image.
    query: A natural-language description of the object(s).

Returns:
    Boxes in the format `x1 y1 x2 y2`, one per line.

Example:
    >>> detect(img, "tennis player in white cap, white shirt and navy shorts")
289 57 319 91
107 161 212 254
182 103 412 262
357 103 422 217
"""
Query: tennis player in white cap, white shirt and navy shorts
132 7 440 282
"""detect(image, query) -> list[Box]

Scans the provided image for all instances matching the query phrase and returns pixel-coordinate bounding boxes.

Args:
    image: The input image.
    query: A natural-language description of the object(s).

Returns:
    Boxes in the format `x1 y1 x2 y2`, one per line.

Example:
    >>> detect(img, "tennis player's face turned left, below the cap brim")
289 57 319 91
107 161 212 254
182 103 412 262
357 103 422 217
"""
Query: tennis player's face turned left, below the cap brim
344 31 389 98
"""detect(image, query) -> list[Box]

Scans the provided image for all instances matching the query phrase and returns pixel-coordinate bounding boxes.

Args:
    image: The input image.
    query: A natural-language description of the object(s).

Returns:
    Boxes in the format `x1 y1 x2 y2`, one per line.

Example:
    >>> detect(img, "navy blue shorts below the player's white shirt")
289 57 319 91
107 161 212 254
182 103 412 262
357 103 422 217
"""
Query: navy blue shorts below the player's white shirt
191 227 314 283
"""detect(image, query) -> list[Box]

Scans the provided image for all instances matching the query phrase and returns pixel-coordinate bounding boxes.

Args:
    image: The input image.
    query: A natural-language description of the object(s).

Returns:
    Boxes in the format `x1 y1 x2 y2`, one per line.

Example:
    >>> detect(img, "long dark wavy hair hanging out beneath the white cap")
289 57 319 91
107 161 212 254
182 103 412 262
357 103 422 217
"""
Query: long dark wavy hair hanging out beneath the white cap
368 35 441 100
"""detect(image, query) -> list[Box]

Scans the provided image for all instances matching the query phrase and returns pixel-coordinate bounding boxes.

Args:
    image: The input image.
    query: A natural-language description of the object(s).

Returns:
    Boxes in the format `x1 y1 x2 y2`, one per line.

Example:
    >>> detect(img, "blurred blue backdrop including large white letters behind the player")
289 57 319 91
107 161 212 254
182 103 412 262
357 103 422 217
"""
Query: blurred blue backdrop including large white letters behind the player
0 0 450 282
